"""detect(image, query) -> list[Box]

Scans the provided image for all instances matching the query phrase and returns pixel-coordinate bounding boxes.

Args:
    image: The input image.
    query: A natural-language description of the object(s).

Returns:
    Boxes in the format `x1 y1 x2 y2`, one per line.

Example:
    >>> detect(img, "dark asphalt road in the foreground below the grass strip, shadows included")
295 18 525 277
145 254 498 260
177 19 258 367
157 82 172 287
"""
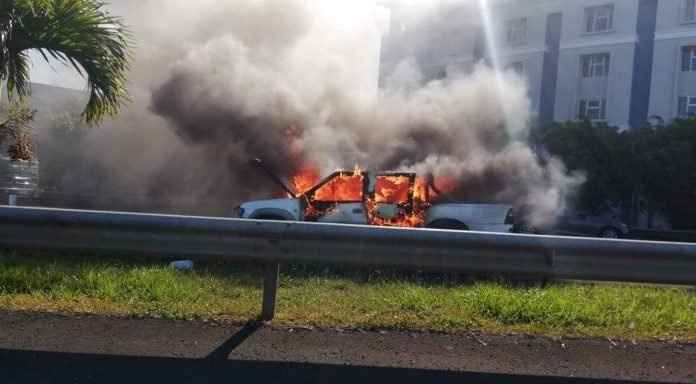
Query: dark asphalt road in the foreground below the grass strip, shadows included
0 311 696 384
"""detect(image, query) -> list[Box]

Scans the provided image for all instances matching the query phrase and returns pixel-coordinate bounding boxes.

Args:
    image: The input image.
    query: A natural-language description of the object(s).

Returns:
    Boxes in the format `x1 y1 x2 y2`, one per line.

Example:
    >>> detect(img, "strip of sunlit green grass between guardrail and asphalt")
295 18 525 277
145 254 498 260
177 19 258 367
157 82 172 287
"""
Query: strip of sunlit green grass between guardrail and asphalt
0 252 696 341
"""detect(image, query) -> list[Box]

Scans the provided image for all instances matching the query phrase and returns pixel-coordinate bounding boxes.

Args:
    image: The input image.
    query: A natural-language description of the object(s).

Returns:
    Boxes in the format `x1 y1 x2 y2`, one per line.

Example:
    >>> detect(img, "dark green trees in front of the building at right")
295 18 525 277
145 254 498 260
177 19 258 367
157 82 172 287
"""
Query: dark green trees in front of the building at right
534 116 696 229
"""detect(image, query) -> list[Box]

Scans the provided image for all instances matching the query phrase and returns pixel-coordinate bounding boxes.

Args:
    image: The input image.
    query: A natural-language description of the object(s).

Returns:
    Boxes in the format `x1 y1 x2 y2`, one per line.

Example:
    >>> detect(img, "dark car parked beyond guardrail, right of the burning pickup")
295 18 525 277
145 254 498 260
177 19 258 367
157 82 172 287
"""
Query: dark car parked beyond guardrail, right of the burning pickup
512 206 628 239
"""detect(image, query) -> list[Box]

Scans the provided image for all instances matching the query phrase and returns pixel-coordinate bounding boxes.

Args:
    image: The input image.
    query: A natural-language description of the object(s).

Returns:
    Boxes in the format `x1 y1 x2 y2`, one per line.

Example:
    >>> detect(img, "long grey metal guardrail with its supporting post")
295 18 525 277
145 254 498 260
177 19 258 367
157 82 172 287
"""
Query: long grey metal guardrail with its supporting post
0 207 696 319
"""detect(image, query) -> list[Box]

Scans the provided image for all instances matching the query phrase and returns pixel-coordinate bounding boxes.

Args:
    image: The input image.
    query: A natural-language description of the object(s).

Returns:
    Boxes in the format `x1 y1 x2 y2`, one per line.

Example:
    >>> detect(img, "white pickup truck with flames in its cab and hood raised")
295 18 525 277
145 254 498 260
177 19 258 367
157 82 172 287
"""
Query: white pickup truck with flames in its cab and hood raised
235 160 513 232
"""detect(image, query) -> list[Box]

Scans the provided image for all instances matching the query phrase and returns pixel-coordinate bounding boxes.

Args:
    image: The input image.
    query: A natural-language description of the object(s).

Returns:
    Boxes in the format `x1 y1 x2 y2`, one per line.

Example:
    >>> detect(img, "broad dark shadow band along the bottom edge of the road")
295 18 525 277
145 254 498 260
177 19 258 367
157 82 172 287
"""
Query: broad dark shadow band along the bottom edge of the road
0 349 676 384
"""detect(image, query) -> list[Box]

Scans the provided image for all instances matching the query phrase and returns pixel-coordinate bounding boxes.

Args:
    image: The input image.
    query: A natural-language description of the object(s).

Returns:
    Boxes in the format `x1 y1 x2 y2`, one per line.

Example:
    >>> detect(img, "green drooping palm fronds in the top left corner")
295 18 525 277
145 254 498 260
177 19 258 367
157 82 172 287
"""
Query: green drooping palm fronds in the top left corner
0 0 132 124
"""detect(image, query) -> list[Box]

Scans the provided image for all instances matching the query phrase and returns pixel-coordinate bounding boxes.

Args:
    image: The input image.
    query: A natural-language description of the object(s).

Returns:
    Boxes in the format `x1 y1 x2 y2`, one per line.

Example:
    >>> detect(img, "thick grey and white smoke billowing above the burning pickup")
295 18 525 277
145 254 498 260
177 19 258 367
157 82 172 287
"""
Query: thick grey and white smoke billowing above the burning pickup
36 0 582 222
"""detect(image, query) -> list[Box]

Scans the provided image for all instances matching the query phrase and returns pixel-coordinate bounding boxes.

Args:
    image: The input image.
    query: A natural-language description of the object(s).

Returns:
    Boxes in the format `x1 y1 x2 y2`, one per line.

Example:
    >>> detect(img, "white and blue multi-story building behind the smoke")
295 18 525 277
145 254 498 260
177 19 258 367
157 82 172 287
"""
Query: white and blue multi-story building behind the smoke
382 0 696 128
